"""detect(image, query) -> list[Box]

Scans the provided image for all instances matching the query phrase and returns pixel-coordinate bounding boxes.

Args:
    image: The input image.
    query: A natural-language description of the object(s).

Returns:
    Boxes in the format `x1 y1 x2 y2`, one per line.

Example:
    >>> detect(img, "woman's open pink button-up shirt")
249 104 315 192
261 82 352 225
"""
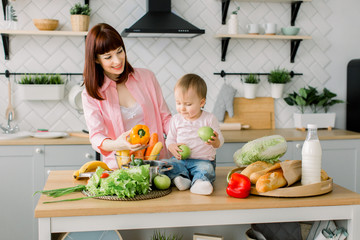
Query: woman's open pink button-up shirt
82 68 171 168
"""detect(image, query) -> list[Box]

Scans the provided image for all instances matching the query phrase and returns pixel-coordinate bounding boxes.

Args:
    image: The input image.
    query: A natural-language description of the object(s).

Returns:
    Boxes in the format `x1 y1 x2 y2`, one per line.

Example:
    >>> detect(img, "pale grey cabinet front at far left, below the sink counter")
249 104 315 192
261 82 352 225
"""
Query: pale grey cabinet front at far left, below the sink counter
0 146 44 240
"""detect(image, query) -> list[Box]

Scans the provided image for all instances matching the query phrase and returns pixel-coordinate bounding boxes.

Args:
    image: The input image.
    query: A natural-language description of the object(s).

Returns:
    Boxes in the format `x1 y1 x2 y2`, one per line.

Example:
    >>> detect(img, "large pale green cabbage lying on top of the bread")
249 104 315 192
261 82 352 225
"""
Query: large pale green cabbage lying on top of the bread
233 135 287 167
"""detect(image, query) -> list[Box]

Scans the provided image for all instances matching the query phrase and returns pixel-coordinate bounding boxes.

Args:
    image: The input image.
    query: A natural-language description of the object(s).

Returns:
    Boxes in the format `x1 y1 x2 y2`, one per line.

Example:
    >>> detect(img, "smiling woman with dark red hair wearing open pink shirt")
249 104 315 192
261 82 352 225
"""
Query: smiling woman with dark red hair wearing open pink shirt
82 23 171 169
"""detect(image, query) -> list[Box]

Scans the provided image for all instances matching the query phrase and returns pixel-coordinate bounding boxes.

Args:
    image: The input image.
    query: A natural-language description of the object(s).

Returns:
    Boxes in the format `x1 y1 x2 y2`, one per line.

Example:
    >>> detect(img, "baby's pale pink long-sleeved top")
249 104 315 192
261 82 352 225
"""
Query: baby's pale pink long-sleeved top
166 111 224 160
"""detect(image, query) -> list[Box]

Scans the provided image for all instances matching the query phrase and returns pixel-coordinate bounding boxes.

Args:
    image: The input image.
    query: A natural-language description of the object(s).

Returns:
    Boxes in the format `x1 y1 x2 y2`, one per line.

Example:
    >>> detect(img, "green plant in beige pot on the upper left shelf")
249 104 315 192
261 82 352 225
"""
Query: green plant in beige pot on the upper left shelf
70 3 91 32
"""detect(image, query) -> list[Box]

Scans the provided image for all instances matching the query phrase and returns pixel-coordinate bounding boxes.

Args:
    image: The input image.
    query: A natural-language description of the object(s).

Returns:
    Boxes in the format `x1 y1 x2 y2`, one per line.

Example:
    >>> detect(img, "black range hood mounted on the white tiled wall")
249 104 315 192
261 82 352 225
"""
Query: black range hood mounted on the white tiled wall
121 0 205 38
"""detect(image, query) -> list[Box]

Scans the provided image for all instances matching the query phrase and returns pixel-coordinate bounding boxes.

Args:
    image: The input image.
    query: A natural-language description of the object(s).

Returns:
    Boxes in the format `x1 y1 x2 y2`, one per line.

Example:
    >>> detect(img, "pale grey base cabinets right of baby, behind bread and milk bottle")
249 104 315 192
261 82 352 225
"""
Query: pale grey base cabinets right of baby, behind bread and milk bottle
216 139 360 193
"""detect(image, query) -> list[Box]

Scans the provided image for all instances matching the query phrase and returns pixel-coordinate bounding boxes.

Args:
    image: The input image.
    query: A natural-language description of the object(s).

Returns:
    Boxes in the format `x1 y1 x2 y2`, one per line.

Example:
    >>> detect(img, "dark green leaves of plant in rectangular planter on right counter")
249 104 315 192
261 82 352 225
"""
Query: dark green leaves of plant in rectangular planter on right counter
284 86 344 113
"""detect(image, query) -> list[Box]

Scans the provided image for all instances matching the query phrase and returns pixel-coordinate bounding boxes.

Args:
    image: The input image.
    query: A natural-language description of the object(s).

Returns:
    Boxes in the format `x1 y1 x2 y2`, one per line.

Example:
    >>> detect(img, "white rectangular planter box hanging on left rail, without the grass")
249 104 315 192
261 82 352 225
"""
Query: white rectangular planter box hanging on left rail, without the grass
18 84 65 100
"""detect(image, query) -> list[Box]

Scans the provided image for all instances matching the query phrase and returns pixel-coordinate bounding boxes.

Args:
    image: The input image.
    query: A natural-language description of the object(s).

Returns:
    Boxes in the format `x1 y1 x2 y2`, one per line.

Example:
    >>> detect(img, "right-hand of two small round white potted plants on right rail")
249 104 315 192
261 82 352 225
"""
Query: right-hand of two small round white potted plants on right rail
268 67 291 98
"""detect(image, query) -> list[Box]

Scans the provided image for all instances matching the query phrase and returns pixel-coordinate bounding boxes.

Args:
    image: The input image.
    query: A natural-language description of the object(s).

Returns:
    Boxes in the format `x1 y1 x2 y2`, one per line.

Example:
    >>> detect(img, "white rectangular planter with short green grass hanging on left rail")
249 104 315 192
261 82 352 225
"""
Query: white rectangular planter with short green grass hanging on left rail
17 74 65 100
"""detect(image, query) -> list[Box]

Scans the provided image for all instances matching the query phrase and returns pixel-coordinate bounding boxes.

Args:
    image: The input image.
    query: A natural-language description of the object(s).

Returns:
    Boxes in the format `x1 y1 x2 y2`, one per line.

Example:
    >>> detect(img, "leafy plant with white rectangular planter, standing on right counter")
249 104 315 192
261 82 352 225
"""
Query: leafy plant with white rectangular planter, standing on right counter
284 86 344 129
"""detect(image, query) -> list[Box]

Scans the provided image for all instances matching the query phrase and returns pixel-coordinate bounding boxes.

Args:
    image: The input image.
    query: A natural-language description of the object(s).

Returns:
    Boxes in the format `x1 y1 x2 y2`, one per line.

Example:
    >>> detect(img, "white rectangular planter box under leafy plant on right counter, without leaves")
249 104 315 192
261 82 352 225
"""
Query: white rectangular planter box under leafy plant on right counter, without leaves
294 113 336 129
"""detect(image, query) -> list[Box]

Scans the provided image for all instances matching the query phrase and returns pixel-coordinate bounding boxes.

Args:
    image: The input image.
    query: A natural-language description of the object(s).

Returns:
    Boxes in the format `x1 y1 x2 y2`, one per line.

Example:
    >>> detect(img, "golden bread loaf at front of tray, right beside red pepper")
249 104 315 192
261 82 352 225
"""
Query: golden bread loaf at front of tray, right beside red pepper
256 169 287 193
